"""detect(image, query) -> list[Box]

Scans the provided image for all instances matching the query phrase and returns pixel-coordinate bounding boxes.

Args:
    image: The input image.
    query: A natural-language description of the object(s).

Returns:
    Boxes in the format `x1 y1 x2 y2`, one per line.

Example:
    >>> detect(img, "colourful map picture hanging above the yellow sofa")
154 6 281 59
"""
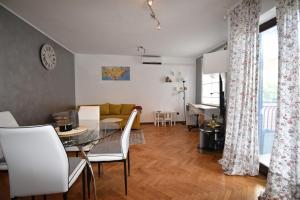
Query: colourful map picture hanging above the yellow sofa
102 66 130 81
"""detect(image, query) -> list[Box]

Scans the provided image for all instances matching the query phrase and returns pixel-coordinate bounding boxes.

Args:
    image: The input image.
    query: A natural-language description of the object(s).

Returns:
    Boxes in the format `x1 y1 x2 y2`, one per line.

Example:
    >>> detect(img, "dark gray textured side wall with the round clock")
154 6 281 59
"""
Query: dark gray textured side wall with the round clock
0 5 75 125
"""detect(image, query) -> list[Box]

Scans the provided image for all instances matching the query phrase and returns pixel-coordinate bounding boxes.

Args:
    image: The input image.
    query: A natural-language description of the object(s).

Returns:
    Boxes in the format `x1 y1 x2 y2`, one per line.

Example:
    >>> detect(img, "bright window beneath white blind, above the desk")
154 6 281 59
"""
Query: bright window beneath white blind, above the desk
201 73 225 106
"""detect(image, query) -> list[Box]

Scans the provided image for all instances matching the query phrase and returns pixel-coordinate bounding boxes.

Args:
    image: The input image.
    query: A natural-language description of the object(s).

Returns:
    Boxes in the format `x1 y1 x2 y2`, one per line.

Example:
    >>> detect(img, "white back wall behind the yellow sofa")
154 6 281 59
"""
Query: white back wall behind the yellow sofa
75 54 196 122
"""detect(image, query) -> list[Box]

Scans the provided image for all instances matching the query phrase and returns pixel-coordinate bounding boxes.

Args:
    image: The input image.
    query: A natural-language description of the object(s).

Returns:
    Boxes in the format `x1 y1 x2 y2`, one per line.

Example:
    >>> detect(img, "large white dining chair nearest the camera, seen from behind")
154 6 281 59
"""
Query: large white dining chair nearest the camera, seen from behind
0 125 86 200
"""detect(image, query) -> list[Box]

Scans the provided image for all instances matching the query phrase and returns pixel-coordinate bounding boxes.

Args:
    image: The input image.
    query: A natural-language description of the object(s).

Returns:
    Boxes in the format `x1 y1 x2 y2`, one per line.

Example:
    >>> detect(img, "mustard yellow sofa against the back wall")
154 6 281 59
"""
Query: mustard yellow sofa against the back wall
100 103 141 129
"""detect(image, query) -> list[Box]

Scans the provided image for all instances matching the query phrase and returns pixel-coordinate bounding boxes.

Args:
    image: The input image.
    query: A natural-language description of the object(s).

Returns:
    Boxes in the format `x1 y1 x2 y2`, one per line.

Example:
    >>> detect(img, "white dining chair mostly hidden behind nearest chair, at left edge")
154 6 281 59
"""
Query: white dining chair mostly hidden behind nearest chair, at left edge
0 111 19 171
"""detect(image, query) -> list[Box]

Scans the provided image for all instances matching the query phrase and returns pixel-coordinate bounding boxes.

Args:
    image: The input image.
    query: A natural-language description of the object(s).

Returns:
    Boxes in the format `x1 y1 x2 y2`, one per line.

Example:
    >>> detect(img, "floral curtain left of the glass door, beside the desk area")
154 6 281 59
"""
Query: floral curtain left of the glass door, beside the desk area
219 0 260 176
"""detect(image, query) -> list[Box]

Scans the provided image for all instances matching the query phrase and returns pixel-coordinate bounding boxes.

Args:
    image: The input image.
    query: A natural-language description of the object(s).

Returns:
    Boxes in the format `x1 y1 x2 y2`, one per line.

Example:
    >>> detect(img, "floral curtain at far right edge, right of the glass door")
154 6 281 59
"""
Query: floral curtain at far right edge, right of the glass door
260 0 300 200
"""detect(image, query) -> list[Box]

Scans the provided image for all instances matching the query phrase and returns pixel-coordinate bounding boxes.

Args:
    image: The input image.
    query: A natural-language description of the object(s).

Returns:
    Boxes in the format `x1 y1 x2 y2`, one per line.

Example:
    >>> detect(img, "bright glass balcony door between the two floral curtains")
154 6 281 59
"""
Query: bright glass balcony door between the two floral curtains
259 23 278 167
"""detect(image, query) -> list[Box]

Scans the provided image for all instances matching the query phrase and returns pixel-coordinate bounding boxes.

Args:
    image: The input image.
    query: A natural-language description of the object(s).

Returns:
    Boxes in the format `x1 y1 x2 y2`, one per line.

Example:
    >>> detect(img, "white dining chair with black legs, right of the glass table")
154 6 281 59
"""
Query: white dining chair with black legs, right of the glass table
87 109 137 195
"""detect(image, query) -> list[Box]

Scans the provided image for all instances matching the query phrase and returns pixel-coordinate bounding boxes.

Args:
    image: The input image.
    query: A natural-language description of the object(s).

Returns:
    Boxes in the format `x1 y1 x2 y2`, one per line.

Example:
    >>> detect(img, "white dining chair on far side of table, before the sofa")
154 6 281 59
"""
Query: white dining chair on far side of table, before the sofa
66 106 100 153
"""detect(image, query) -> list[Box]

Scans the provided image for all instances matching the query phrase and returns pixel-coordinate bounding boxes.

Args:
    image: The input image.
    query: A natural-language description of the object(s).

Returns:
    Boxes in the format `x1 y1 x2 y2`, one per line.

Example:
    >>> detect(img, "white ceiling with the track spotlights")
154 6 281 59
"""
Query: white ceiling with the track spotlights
0 0 239 58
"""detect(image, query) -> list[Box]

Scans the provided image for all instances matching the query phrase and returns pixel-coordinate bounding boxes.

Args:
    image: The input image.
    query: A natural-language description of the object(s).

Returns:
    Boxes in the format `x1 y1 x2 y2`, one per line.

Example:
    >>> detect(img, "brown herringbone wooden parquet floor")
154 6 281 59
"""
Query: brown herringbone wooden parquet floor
0 124 266 200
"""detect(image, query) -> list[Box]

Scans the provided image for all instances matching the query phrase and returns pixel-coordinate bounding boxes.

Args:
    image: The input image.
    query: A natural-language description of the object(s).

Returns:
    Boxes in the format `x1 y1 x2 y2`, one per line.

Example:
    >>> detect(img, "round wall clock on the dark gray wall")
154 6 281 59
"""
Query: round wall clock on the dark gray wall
41 44 56 70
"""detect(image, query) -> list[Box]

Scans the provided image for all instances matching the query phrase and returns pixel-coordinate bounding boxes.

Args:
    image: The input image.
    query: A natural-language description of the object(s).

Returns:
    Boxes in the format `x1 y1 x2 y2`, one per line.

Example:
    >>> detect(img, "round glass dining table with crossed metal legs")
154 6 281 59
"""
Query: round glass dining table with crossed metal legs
56 120 120 199
